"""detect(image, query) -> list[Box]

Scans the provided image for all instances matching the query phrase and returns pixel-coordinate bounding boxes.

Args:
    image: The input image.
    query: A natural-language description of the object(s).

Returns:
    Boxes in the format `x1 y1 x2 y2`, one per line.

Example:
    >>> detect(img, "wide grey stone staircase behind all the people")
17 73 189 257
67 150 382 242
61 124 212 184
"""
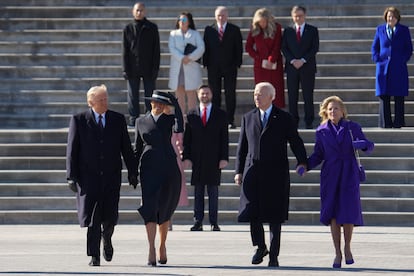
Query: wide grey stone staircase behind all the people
0 0 414 225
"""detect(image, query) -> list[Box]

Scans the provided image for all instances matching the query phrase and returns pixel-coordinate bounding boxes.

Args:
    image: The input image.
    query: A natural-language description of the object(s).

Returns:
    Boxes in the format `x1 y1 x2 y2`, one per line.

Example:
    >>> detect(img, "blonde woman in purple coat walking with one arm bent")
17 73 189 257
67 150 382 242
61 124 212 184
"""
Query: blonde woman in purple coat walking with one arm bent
308 96 374 268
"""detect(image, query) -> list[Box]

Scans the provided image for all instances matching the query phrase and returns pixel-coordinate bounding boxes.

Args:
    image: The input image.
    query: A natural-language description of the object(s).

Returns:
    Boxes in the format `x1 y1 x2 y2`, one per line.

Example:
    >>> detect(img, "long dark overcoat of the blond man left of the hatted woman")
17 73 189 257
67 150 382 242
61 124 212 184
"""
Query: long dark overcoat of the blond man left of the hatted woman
66 109 137 227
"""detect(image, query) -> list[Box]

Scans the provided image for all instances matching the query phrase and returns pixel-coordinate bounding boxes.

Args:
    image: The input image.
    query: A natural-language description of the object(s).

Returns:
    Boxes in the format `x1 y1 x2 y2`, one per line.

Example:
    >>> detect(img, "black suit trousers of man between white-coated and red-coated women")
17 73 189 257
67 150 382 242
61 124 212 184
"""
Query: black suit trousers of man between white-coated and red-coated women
208 68 237 124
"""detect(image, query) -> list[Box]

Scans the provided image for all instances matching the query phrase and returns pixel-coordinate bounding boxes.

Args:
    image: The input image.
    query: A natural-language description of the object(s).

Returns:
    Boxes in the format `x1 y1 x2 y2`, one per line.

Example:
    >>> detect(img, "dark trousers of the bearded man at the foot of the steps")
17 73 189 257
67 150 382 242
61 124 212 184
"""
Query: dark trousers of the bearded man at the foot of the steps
194 185 218 224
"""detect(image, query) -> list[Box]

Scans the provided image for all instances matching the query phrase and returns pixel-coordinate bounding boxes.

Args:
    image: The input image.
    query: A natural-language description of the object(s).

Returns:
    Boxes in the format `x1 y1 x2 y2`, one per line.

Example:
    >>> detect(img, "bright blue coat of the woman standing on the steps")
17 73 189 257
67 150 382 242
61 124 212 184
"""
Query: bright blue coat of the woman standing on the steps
371 23 413 96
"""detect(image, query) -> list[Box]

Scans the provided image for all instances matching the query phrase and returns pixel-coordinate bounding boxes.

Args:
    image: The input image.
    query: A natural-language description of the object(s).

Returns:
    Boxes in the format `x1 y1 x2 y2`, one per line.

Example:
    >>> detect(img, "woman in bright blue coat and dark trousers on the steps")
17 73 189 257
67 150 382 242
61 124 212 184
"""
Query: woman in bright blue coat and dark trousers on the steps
371 7 413 128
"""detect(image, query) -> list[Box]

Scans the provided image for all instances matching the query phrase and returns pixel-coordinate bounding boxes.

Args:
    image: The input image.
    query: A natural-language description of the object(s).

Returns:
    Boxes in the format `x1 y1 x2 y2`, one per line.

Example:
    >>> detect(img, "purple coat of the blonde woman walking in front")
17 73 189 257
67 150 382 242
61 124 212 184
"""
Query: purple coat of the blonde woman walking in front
308 120 374 225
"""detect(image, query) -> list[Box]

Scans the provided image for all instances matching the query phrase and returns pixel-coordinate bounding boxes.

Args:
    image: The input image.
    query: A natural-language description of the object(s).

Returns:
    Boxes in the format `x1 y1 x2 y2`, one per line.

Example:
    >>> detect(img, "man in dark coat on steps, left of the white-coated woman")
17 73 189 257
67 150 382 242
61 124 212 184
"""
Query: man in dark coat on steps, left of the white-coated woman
122 2 160 127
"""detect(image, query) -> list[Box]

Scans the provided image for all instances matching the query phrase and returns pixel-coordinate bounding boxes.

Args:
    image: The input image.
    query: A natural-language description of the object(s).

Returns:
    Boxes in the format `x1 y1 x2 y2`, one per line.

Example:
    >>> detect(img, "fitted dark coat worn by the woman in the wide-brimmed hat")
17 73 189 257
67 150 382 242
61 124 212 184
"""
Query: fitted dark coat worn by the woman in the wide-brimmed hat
134 112 183 224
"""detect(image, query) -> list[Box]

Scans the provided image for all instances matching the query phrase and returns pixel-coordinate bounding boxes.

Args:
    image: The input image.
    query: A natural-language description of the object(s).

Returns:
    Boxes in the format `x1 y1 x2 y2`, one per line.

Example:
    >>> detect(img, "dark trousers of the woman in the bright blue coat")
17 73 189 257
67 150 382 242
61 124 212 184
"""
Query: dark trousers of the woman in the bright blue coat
378 95 405 128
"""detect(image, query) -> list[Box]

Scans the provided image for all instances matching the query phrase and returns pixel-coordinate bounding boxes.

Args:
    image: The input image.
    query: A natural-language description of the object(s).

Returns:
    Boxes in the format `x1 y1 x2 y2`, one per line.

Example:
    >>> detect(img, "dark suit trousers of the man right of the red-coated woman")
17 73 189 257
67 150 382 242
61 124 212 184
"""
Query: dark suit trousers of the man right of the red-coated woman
286 65 315 125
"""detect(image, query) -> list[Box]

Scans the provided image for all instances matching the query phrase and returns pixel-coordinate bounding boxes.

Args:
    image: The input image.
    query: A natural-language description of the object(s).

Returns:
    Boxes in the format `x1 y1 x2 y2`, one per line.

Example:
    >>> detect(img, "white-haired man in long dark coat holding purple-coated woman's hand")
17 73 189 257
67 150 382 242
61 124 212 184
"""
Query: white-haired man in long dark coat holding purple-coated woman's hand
234 82 306 266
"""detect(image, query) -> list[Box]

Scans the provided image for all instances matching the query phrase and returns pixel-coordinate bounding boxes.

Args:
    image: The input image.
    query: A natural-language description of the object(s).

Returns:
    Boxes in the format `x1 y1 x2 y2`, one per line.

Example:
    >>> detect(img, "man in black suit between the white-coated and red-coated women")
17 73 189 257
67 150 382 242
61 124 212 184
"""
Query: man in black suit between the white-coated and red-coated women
203 6 243 128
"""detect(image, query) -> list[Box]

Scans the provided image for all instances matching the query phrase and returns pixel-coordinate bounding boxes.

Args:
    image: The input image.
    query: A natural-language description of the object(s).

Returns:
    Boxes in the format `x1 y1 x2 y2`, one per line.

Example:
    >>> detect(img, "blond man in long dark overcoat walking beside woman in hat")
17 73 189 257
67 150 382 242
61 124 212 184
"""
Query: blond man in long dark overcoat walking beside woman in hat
66 85 138 266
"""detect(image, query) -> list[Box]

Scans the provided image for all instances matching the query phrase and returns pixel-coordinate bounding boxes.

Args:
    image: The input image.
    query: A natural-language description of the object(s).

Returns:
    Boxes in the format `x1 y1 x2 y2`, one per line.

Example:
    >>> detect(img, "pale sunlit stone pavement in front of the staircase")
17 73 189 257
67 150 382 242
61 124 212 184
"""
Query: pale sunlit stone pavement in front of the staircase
0 222 414 276
